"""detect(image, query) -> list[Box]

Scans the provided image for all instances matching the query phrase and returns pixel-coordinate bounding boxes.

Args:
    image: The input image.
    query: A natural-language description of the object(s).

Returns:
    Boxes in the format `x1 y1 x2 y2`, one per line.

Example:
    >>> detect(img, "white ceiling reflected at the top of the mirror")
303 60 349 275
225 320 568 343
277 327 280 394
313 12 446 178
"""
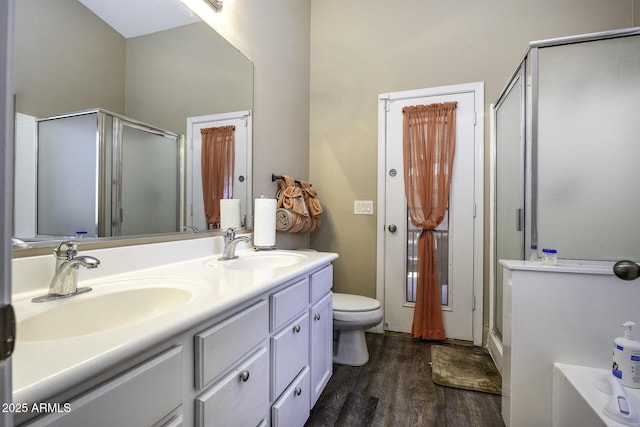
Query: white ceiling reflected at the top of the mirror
79 0 200 38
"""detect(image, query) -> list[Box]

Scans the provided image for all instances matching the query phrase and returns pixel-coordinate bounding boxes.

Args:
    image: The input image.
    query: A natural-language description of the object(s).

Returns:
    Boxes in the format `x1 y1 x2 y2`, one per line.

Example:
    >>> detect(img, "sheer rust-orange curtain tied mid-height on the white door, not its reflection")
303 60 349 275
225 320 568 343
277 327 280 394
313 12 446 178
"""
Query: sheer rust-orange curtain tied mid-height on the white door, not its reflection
402 102 457 340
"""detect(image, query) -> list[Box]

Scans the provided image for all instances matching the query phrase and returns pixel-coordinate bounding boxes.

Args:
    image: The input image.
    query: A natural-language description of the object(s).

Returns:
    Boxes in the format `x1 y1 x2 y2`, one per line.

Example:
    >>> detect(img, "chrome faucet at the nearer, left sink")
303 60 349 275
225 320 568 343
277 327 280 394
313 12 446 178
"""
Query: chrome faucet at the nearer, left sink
32 241 100 302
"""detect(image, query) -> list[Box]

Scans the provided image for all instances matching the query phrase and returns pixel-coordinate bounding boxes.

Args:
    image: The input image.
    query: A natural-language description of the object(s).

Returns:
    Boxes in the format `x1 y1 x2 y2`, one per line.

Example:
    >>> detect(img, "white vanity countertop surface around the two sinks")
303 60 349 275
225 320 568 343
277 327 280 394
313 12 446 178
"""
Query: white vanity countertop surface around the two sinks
12 246 338 403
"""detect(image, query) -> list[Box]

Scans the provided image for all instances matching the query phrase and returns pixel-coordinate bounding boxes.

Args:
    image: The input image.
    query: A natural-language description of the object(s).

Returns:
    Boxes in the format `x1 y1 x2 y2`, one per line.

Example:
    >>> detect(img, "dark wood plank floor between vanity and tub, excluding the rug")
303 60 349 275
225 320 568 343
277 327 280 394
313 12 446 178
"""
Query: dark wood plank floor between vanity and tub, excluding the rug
305 334 504 427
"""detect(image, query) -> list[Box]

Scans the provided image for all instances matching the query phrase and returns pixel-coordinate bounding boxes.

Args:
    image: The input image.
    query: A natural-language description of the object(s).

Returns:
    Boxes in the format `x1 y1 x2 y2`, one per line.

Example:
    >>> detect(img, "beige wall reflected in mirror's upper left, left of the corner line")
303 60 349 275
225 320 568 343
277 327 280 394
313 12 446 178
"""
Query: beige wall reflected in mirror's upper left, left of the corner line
14 0 125 117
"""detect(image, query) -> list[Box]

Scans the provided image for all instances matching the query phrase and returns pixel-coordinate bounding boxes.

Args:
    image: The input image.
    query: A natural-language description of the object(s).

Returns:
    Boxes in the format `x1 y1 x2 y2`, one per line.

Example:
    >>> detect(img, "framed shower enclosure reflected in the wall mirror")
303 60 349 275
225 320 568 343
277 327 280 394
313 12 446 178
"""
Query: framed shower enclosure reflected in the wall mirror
36 109 184 237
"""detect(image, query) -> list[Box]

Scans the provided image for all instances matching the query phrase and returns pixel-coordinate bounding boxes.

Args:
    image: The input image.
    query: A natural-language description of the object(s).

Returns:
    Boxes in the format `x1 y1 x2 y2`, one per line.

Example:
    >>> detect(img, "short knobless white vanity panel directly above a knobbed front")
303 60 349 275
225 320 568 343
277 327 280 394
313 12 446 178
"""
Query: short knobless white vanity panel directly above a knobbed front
195 300 269 390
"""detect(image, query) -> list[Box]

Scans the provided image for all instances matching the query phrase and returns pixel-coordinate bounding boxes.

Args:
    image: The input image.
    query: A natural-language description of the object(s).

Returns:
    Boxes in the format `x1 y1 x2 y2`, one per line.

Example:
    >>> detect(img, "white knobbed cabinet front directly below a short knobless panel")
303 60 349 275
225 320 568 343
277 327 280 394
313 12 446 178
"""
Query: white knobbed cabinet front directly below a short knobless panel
195 347 269 426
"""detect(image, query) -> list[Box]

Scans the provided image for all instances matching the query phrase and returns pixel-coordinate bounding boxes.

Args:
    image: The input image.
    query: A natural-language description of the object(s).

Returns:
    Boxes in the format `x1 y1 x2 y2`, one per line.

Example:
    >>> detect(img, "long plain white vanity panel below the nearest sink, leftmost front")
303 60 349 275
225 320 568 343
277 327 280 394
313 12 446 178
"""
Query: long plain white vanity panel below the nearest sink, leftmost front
28 347 183 427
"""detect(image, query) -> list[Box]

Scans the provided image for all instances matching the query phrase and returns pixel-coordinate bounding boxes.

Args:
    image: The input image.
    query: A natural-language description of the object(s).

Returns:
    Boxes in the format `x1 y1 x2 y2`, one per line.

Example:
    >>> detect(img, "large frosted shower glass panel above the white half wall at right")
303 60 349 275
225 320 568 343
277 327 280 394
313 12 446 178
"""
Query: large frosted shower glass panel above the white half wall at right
536 36 640 261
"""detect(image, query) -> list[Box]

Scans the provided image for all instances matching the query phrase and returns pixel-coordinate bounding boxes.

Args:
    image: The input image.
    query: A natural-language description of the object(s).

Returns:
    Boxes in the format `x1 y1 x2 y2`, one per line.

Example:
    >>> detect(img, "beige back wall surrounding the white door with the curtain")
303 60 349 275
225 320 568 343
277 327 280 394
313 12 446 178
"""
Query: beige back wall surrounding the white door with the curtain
309 0 638 310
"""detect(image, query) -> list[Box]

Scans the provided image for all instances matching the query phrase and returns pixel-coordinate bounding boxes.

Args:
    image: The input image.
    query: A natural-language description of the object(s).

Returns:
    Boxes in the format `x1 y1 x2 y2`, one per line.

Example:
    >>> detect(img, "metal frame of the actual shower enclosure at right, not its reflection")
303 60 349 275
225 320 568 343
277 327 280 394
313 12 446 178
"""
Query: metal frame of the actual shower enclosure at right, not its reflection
488 28 640 372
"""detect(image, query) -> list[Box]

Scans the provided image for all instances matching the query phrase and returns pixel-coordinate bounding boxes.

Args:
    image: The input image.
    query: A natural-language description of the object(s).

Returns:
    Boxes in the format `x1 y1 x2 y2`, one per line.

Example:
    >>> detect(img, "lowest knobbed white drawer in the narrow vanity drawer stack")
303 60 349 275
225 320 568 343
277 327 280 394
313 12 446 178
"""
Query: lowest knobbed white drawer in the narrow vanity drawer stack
271 368 311 427
